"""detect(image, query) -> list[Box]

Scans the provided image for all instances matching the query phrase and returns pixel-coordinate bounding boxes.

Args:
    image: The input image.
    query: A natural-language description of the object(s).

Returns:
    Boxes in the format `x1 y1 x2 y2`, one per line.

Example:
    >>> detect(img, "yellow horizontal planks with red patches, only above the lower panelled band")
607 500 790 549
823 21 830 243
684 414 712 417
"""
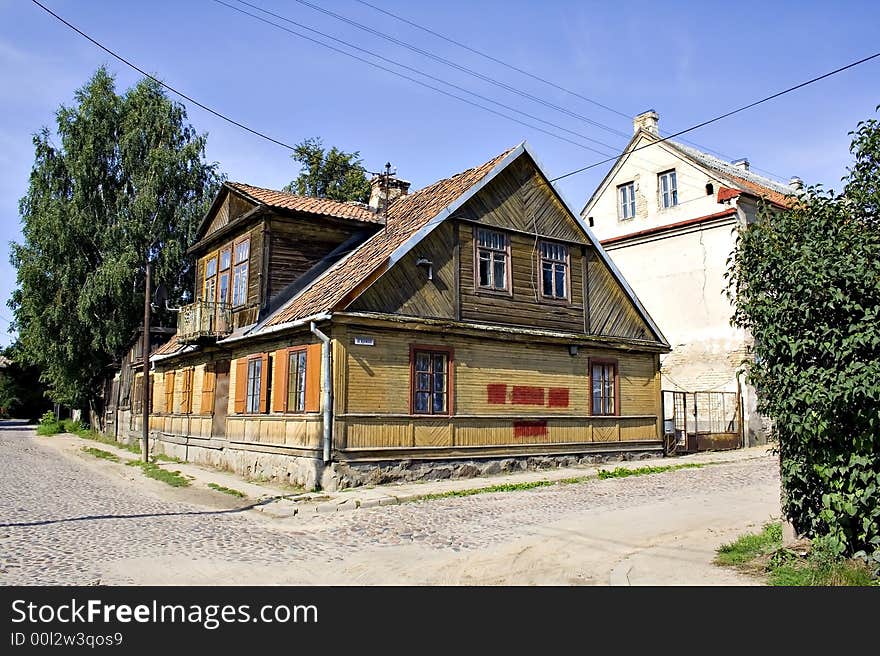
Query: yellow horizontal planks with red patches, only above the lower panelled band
337 328 660 416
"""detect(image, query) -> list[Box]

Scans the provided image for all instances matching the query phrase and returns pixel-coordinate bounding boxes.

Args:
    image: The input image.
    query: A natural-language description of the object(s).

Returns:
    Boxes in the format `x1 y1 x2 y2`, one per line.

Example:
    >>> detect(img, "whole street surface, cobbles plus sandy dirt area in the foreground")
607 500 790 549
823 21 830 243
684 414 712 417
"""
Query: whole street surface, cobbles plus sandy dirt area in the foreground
0 425 778 585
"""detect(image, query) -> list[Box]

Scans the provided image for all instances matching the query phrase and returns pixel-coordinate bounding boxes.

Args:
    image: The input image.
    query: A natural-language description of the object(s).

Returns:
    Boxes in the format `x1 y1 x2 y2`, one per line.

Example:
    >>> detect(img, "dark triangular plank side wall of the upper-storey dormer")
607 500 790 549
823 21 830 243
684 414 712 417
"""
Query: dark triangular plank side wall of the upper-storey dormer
265 216 357 301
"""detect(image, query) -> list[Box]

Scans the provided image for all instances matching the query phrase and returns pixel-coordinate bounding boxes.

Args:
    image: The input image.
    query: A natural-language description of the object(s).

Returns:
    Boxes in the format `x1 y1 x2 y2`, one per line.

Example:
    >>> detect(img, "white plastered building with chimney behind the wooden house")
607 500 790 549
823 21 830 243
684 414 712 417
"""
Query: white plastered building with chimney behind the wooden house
581 110 801 445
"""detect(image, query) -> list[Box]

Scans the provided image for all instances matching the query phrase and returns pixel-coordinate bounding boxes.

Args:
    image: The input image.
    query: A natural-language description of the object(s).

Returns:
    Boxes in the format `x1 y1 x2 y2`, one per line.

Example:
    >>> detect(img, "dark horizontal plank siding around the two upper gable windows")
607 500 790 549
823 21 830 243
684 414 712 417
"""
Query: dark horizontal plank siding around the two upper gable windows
459 228 584 333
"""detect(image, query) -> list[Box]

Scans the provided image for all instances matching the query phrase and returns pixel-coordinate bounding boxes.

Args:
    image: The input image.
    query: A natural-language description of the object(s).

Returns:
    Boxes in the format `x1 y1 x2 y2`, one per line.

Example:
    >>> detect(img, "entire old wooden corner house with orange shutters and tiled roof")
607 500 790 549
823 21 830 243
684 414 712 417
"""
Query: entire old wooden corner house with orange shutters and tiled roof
139 143 669 489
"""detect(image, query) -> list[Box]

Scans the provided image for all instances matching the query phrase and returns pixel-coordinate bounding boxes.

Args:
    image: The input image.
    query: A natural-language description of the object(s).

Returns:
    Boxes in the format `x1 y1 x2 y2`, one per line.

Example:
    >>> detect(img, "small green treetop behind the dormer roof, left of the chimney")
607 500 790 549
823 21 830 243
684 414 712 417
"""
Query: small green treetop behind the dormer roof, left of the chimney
284 138 370 203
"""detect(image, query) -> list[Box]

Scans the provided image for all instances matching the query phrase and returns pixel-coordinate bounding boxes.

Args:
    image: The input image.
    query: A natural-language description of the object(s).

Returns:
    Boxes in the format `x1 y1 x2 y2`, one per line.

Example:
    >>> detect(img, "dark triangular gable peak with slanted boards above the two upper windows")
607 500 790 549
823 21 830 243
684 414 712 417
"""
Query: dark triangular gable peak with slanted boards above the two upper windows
452 157 588 244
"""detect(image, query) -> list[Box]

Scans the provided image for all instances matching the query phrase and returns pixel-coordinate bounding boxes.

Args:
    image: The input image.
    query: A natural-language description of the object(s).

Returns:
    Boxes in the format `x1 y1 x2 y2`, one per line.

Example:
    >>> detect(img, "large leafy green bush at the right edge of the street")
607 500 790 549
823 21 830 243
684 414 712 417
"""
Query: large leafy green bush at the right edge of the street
728 107 880 556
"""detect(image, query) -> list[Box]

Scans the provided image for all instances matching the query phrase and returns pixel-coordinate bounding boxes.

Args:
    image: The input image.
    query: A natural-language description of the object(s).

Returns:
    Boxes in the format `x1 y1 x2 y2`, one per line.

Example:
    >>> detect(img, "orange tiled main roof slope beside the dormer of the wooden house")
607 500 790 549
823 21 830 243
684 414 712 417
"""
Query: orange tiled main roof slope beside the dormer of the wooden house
256 148 513 332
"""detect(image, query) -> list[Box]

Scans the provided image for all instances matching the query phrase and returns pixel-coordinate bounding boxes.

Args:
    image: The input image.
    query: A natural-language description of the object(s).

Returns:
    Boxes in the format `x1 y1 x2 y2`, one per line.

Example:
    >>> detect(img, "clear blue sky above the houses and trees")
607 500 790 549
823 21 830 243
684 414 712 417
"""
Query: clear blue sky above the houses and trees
0 0 880 345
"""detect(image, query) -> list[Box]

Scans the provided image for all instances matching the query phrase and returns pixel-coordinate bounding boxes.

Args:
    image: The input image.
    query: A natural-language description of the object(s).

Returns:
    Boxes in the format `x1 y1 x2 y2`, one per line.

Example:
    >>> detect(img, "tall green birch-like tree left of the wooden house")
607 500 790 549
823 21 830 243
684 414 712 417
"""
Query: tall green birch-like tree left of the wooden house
9 68 221 416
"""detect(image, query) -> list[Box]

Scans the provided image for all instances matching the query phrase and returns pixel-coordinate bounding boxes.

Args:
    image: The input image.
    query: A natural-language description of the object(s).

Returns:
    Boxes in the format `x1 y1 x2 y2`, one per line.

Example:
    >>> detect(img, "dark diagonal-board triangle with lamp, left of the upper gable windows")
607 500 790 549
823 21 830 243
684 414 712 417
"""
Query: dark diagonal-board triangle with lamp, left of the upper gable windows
347 223 456 319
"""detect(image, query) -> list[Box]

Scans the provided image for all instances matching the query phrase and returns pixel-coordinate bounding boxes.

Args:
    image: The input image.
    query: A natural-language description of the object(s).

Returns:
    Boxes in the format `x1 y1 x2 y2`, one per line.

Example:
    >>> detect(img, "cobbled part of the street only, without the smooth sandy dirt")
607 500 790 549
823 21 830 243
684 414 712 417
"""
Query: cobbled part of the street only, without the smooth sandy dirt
0 425 778 585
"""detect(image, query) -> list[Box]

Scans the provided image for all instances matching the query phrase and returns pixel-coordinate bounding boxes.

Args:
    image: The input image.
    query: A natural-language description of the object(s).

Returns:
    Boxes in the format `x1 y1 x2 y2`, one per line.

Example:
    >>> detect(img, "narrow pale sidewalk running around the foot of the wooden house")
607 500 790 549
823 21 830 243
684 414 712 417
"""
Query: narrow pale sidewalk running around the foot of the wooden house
48 433 772 518
